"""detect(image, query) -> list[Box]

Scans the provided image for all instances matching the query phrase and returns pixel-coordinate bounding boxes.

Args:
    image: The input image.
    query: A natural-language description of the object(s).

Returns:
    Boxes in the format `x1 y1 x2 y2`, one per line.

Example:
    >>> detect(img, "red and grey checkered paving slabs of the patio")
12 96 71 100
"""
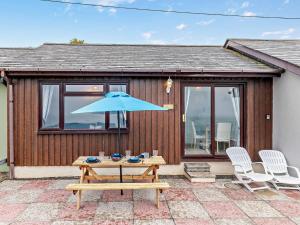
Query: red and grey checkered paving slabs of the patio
0 179 300 225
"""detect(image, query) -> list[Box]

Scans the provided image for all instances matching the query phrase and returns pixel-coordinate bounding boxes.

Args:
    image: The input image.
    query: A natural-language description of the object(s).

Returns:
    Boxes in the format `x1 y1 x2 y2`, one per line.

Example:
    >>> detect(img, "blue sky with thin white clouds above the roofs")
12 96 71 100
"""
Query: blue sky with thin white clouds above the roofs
0 0 300 47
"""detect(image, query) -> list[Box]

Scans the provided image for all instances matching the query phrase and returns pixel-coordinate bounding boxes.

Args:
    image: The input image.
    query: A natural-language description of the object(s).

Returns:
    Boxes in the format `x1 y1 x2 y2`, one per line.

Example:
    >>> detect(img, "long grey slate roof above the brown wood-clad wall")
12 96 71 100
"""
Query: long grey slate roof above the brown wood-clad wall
0 44 271 72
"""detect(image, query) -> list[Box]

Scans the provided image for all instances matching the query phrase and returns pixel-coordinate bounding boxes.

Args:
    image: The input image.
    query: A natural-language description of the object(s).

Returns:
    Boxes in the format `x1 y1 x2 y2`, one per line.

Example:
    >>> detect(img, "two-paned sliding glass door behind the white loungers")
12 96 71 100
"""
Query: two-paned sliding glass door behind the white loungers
182 84 243 157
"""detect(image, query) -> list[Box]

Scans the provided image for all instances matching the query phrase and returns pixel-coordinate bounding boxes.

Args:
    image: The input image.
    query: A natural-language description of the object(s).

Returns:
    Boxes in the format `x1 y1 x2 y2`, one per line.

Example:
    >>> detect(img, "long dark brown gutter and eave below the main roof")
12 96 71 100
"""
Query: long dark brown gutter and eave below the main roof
6 68 283 78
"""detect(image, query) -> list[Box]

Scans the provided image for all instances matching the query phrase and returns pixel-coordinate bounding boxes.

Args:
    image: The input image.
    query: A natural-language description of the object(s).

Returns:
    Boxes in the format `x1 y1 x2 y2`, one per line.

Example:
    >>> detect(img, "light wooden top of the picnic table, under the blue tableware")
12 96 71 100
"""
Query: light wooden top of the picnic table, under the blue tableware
72 156 166 168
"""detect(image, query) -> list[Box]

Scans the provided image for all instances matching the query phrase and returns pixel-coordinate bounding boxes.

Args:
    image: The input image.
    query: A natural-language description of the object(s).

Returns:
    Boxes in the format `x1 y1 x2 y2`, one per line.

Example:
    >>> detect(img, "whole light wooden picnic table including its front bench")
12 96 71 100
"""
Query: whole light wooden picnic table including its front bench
66 156 170 209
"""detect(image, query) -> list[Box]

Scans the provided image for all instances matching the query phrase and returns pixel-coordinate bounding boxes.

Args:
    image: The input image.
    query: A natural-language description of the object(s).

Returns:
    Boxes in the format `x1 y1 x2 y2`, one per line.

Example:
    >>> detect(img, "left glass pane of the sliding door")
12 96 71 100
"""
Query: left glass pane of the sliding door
184 86 211 156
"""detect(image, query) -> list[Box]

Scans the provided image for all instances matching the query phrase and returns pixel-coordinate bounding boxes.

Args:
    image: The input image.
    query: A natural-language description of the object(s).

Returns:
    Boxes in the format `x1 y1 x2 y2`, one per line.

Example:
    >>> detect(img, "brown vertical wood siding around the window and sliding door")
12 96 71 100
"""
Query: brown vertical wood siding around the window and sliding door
14 75 272 166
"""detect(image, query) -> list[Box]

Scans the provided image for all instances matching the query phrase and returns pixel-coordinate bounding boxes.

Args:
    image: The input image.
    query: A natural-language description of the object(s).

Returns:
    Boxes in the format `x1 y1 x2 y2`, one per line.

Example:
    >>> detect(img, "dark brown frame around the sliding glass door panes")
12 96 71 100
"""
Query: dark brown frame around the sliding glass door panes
180 80 247 161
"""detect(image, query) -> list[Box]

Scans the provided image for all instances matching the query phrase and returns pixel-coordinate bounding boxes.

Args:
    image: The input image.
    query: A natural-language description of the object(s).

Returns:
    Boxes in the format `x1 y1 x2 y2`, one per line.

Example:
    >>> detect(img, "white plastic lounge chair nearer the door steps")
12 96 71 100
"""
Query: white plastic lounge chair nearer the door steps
226 147 273 192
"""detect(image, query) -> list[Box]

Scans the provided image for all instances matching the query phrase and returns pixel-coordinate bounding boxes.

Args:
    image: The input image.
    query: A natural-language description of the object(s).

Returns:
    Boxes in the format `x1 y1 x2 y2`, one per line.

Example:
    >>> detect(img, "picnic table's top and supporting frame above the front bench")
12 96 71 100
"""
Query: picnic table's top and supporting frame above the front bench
72 156 166 183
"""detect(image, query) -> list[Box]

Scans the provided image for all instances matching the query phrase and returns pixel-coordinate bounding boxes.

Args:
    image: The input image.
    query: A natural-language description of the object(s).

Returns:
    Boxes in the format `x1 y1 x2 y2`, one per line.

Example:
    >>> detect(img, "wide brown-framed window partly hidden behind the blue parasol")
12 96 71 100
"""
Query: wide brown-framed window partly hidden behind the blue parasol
40 83 128 131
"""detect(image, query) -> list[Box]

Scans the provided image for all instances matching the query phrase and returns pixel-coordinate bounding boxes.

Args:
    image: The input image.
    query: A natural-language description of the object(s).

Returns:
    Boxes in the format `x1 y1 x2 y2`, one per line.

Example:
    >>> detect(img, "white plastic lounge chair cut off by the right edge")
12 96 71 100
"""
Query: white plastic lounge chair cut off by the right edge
259 150 300 191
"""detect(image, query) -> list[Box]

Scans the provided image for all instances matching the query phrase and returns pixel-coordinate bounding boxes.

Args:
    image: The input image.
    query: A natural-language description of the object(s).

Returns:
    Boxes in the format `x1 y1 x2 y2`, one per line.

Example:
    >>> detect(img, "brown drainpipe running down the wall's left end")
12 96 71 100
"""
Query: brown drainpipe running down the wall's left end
1 70 15 179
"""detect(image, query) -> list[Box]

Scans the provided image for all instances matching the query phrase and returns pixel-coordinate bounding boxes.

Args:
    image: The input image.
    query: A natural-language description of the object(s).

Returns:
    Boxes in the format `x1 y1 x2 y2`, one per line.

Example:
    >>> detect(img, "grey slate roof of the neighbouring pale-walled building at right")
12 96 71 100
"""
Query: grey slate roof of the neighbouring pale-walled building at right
229 39 300 66
